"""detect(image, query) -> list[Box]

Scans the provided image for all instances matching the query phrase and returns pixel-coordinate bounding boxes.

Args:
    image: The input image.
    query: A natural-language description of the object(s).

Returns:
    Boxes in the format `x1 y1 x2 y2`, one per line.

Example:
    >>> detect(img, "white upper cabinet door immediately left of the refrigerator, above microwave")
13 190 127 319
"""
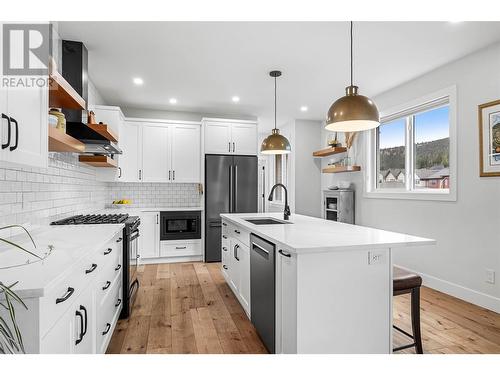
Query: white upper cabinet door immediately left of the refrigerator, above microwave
170 124 201 182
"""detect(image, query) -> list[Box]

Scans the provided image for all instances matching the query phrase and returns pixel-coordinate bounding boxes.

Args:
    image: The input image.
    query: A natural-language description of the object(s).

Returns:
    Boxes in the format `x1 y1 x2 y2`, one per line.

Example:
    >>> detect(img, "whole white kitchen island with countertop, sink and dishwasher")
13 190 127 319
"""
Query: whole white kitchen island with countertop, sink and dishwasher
221 213 435 353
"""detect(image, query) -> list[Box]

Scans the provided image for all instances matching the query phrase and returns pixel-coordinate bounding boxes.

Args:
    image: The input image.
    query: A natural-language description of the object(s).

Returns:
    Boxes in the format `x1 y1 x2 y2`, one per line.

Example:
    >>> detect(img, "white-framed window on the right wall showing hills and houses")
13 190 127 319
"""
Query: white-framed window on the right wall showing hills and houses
366 89 456 200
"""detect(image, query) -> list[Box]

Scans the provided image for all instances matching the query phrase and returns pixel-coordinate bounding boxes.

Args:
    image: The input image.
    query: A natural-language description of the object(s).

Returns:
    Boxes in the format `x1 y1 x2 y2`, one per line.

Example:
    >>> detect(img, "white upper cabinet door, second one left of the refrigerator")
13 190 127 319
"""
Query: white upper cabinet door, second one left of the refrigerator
139 123 171 182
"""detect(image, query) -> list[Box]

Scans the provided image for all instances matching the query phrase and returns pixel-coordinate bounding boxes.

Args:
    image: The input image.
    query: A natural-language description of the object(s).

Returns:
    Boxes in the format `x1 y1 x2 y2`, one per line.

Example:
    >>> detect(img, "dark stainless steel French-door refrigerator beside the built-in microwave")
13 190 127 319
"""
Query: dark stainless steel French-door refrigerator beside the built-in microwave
205 155 257 262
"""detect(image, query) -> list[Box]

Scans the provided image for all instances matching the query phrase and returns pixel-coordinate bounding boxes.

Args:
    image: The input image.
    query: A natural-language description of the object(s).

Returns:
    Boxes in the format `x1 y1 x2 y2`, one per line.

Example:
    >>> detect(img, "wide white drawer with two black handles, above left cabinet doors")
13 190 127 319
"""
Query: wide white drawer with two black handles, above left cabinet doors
40 254 99 336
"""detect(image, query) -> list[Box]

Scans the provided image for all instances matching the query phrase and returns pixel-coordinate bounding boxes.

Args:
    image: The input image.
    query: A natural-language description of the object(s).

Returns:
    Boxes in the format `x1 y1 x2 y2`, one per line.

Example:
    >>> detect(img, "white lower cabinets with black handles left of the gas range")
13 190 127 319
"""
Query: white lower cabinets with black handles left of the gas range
5 231 122 354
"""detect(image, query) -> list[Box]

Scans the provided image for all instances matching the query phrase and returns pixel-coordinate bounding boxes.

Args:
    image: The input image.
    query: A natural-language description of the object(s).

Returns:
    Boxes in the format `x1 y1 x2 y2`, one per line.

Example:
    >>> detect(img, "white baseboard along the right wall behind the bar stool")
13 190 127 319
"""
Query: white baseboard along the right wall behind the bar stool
397 265 500 314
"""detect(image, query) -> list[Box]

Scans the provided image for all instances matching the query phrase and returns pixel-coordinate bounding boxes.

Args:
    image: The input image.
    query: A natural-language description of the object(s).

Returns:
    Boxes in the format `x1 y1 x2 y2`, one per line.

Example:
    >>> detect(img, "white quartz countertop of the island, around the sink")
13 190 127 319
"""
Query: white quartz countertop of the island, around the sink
220 213 436 253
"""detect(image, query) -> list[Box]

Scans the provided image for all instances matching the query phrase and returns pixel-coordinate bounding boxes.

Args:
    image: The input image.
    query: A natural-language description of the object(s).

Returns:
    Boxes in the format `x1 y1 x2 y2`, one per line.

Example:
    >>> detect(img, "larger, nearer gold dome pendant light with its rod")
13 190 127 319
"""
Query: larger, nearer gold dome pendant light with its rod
325 21 380 132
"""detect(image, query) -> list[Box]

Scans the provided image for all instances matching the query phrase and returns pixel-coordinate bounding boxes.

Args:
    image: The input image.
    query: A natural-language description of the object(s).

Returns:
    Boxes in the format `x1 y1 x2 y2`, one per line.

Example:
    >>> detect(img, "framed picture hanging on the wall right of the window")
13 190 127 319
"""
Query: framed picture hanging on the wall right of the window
478 100 500 177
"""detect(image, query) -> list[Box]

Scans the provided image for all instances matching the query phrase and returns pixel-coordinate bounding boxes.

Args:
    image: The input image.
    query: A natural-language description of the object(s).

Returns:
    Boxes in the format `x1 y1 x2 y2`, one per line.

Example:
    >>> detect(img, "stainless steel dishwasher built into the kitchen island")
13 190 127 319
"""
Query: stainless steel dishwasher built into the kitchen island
250 234 276 353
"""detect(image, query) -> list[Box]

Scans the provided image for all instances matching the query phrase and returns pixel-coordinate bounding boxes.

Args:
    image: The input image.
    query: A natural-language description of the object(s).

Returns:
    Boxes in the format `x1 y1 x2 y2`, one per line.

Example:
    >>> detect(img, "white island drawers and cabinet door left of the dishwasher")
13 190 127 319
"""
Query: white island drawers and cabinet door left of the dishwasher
221 223 250 316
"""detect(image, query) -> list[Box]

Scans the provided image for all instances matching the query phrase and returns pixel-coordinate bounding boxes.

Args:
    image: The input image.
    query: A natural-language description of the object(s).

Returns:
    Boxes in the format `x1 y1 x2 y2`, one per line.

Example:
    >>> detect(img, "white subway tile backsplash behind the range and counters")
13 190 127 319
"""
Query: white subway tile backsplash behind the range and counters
0 153 202 225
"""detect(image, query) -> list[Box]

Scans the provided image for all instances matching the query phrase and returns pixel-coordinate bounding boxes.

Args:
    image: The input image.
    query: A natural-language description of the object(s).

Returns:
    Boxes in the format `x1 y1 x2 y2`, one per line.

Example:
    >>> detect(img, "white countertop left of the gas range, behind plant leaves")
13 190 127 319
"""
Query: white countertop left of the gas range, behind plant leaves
0 224 124 298
